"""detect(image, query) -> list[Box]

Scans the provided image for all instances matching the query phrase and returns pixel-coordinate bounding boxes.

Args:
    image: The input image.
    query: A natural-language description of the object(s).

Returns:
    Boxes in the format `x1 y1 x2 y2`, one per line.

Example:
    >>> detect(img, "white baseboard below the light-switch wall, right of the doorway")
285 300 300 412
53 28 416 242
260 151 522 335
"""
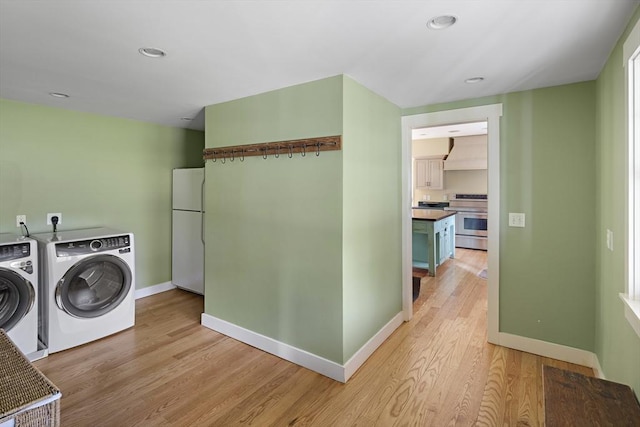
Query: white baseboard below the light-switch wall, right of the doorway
494 332 604 378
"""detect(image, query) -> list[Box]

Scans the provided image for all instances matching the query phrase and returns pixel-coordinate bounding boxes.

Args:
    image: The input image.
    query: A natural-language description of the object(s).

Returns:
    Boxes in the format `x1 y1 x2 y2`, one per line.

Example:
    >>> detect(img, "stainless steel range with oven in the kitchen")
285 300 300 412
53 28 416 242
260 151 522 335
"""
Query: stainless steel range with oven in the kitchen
444 194 488 251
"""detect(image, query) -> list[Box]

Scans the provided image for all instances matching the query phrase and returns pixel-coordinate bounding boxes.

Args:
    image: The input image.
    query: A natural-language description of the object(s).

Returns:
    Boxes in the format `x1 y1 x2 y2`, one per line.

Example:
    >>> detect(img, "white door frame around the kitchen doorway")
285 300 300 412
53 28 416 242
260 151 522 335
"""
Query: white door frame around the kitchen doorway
402 104 502 343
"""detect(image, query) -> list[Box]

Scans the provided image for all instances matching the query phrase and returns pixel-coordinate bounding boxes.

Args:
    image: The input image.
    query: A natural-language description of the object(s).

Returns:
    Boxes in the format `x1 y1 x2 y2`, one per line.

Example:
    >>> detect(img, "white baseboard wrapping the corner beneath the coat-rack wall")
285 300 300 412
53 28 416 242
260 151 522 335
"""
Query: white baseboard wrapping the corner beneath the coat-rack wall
201 313 402 383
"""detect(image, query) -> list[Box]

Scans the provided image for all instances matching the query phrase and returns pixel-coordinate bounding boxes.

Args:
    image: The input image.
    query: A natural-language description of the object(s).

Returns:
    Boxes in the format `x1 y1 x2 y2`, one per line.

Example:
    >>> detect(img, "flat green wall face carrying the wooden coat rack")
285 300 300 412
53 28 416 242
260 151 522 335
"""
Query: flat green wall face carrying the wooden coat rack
205 77 342 362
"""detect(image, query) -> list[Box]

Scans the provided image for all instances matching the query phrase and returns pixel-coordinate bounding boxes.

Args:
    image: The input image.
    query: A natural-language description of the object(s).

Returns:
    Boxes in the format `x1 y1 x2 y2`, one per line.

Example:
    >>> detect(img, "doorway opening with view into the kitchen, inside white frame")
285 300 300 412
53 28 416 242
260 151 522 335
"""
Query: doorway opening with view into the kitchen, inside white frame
411 121 489 332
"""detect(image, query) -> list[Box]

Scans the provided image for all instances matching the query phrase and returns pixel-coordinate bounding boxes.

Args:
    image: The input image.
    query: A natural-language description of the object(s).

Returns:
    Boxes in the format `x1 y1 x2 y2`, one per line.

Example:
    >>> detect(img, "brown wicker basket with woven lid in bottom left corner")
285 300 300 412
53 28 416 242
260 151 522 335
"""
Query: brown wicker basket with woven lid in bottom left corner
0 329 62 427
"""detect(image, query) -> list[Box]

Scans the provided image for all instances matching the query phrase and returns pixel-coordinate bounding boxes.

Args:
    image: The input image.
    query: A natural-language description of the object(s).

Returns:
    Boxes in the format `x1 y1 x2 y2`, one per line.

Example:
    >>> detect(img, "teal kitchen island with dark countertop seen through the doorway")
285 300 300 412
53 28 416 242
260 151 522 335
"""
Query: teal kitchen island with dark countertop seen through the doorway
411 208 456 276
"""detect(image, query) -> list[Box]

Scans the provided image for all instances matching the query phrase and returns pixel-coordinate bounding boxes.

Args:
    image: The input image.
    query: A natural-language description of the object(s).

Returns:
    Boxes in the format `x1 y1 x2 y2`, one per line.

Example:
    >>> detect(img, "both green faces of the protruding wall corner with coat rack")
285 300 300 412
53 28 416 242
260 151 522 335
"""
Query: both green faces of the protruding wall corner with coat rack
205 76 401 364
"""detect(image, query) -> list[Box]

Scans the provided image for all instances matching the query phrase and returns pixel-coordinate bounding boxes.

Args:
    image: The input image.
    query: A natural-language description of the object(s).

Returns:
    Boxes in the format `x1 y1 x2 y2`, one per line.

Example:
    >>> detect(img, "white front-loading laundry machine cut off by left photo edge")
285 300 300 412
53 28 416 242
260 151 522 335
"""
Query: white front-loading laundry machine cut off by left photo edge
0 234 38 359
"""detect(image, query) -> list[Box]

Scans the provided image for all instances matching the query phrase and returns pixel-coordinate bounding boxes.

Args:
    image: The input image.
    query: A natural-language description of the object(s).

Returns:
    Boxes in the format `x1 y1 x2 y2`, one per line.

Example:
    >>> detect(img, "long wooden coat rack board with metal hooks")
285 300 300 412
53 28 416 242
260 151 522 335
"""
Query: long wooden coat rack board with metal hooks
203 135 342 163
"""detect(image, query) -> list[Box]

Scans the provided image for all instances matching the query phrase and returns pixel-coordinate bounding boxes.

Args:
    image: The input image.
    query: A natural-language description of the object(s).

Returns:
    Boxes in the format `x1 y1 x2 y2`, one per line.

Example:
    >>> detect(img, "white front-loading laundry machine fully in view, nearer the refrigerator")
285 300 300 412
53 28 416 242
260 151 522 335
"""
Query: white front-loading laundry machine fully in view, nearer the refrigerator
32 228 135 353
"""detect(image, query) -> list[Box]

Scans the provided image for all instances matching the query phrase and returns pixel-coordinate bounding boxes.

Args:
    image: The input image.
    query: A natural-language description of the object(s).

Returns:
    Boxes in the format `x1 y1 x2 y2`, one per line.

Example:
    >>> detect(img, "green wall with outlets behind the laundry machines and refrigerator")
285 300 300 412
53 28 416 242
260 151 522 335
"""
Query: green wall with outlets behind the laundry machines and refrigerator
0 99 204 288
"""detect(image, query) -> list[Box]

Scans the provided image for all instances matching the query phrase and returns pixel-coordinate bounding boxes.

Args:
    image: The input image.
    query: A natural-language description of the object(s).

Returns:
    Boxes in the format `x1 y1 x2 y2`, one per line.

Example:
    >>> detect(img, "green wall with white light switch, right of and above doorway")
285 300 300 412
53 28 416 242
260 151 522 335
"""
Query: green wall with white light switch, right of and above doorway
403 82 596 351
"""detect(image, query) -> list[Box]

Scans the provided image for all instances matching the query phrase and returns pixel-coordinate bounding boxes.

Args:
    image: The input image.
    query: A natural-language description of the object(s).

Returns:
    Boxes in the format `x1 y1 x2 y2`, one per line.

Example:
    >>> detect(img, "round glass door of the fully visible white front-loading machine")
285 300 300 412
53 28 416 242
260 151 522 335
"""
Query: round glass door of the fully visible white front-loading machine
56 255 131 318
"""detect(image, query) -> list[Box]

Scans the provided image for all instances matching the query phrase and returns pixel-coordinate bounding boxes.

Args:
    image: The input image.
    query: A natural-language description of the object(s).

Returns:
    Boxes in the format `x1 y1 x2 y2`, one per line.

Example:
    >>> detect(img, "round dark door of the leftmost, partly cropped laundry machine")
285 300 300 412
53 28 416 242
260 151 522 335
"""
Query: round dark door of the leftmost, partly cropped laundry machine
0 268 35 332
